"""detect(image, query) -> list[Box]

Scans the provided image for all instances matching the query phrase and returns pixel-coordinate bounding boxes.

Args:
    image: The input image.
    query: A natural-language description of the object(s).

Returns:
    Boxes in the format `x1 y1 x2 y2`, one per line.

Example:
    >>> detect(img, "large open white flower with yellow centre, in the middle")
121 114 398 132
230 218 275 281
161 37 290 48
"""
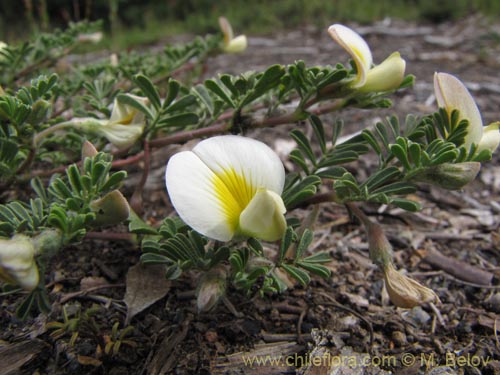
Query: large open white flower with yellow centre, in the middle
165 135 286 241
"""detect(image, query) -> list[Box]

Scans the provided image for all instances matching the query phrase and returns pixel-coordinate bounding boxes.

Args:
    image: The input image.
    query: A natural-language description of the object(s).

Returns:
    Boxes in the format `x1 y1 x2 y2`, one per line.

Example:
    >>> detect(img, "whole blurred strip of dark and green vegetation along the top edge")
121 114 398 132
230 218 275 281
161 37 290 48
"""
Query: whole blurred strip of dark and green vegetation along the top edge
0 0 500 46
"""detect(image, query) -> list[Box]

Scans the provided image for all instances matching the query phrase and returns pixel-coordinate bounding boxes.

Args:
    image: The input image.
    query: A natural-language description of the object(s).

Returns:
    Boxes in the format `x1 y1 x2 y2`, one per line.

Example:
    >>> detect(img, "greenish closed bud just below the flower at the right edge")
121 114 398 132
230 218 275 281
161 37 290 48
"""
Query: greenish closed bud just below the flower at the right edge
411 161 481 190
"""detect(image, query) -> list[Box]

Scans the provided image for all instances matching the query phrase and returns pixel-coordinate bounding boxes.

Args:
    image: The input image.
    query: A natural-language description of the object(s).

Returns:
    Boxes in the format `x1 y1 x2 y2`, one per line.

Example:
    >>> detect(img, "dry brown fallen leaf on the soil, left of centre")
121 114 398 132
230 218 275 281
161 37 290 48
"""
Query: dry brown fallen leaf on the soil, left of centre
124 264 170 326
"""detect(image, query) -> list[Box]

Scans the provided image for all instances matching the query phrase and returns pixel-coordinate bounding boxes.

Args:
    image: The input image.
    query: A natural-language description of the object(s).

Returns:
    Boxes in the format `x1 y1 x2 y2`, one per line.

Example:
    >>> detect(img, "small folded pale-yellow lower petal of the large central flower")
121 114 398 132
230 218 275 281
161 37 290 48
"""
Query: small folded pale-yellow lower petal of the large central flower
239 189 286 241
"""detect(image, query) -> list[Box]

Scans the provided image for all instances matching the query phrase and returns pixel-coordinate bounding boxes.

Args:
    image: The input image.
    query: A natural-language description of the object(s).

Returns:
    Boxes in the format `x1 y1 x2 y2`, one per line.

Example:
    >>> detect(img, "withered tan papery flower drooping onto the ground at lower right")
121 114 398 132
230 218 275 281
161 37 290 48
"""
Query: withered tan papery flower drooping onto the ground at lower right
383 263 439 309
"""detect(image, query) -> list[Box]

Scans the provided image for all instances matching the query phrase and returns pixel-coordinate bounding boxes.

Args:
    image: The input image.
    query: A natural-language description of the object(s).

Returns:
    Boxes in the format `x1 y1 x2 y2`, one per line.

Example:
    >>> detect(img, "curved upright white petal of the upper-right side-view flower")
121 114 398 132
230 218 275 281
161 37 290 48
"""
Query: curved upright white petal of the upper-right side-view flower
328 24 373 88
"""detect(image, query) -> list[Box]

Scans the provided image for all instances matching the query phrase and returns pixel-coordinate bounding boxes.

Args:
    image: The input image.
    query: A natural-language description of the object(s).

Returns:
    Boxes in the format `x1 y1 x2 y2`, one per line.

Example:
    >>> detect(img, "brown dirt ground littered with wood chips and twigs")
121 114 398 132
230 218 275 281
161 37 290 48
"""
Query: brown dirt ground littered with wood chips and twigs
0 17 500 375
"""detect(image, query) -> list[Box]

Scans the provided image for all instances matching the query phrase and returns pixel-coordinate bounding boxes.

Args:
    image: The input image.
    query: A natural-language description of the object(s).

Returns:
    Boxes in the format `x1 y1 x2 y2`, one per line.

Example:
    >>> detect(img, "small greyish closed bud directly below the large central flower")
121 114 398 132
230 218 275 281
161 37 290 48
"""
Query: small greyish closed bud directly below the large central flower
196 267 227 312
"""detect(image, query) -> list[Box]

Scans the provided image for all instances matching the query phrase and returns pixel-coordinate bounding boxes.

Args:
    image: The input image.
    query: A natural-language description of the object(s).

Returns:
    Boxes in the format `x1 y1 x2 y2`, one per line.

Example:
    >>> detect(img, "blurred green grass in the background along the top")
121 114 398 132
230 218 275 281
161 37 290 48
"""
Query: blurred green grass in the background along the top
0 0 500 50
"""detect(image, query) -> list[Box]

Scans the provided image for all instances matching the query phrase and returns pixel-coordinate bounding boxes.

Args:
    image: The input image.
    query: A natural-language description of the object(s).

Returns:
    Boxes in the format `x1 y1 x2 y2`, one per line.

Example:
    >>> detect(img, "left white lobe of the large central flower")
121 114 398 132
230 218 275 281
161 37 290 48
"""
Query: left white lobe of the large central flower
165 151 234 241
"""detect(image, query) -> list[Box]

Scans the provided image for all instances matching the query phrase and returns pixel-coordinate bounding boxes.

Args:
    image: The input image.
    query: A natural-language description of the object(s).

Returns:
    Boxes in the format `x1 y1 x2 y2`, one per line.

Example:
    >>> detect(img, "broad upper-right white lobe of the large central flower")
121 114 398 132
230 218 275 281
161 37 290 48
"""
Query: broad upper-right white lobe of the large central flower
193 135 285 196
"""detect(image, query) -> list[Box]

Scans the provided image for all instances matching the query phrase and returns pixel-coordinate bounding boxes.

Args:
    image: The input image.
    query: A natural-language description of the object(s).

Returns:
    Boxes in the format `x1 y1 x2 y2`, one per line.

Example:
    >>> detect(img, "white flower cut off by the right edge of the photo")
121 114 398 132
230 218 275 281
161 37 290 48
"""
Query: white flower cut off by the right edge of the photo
434 73 500 152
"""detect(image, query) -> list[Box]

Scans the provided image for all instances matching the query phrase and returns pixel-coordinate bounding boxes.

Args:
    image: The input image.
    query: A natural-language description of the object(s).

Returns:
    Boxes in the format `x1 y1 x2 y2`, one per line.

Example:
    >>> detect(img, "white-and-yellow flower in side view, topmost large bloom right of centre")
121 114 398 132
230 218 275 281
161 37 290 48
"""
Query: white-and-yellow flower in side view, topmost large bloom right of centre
328 24 406 92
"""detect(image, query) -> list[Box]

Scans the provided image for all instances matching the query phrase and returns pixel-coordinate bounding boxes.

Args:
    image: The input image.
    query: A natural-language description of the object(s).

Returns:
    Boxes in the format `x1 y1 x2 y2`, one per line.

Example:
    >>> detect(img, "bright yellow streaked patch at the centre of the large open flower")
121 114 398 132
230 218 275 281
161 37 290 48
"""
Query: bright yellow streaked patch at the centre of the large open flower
212 168 257 231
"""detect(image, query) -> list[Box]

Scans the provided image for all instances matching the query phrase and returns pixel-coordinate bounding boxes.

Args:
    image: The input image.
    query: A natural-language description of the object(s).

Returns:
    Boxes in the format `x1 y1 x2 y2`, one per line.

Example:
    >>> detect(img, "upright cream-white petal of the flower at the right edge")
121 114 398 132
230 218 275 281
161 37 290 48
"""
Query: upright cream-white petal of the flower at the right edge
434 73 483 149
